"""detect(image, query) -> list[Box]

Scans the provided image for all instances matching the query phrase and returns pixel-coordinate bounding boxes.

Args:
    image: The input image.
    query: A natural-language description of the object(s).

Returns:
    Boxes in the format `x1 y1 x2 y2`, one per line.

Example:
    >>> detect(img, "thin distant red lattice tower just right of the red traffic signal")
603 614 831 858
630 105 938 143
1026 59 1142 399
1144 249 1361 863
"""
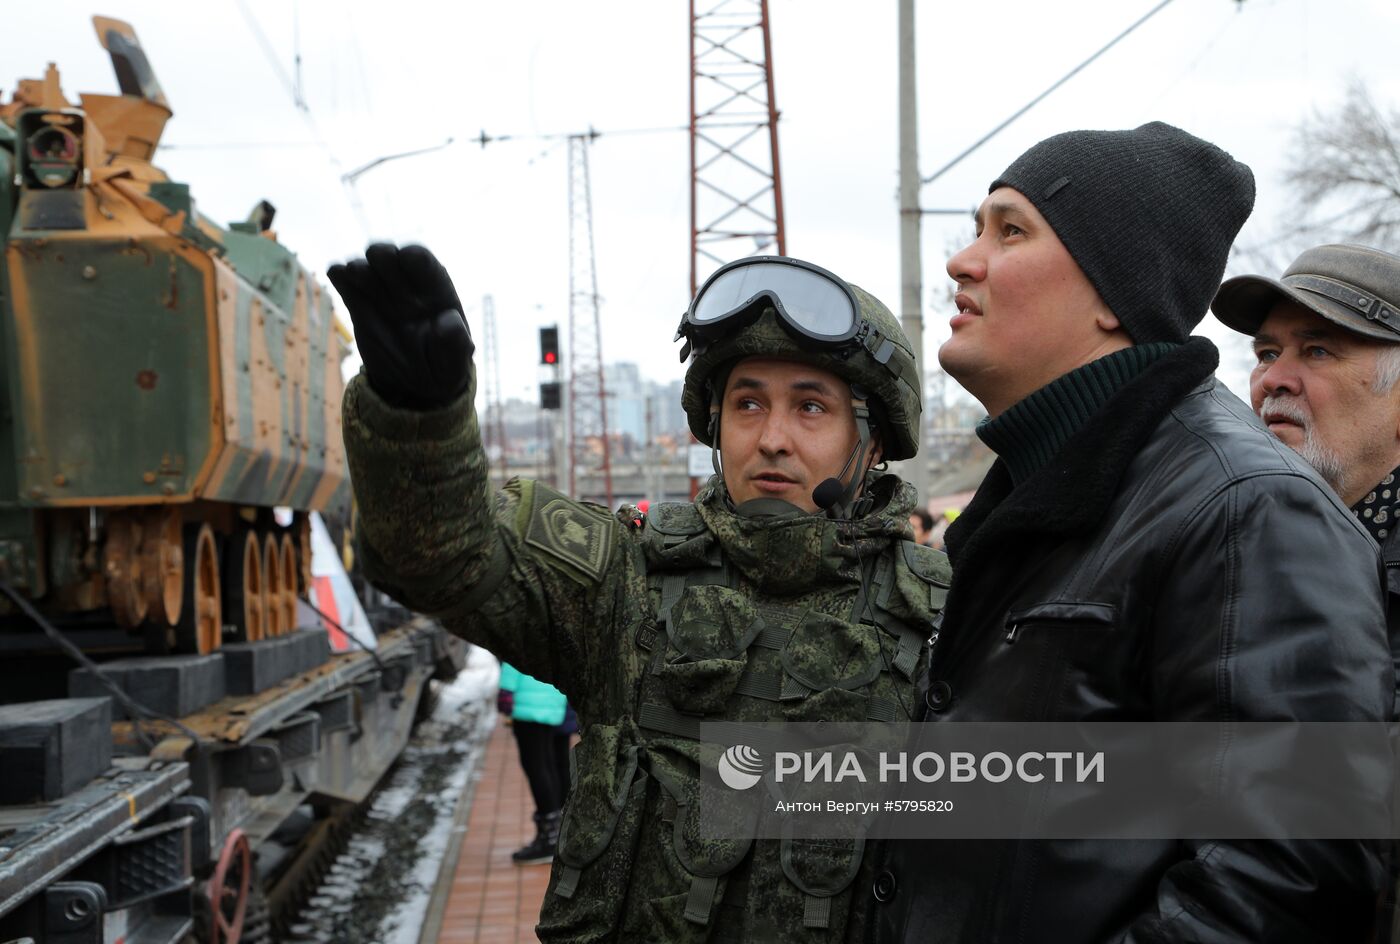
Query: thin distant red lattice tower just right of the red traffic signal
567 133 612 508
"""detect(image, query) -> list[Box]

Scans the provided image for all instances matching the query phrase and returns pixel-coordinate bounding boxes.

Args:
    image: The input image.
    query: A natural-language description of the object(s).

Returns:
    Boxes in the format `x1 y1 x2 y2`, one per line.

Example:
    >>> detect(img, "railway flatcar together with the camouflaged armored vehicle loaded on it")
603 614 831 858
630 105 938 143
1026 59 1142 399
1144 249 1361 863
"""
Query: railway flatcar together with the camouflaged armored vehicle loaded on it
0 17 465 944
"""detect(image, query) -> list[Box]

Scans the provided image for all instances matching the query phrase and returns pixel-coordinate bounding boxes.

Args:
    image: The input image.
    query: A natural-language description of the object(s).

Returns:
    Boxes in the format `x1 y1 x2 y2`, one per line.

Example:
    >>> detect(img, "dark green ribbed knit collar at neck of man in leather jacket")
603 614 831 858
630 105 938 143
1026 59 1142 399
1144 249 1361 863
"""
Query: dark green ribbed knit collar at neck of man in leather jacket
977 342 1180 485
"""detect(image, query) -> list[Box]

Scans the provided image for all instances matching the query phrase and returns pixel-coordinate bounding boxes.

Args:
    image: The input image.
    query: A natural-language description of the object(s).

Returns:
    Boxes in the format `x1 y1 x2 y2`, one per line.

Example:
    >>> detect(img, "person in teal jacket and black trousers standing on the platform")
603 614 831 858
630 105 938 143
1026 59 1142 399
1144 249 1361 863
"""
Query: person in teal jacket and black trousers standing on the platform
497 662 578 866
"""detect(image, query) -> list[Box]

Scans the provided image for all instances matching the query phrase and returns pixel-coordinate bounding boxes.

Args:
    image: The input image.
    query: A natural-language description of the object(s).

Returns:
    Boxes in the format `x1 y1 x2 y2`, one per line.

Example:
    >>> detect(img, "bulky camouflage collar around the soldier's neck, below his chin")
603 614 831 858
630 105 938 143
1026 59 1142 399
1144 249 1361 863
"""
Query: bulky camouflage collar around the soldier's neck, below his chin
696 472 916 594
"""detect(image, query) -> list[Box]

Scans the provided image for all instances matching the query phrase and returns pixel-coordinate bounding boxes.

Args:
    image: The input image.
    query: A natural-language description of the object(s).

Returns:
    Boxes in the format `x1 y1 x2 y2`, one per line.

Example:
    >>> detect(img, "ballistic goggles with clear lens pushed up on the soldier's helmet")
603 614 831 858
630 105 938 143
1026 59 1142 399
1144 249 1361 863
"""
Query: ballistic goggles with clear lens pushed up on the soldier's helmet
675 256 895 364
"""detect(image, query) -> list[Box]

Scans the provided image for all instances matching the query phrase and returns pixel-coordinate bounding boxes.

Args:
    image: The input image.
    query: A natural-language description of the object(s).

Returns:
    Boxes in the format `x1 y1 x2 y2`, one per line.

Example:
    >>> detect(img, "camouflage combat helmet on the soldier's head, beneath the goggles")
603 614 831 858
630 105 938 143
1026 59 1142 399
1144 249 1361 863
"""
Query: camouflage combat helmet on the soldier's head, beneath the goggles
678 256 923 459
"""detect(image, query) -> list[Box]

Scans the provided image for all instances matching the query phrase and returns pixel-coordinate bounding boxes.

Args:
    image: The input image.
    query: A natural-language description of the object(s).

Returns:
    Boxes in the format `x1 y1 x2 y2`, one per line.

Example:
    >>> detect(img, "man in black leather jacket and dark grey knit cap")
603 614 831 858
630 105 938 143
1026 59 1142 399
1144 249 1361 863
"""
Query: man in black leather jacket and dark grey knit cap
867 123 1394 944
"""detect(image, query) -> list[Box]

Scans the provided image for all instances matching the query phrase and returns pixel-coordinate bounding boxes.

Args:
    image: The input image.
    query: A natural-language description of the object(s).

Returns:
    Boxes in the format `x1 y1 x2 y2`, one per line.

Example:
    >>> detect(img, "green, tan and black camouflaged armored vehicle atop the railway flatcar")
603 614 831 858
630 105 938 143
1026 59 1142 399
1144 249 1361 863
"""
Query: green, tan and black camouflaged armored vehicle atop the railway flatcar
0 17 349 653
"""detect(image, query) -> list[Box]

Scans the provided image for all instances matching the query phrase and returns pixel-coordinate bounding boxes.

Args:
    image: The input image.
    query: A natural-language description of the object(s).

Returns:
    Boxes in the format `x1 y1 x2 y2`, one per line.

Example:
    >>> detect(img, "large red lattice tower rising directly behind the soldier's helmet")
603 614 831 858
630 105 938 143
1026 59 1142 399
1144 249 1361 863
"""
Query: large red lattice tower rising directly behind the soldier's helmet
690 0 787 297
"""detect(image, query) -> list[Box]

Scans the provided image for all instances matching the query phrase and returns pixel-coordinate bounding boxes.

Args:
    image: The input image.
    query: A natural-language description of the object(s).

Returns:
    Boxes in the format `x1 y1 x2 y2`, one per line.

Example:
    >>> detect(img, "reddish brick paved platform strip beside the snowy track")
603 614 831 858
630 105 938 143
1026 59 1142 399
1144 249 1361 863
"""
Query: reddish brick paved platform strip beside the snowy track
437 723 549 944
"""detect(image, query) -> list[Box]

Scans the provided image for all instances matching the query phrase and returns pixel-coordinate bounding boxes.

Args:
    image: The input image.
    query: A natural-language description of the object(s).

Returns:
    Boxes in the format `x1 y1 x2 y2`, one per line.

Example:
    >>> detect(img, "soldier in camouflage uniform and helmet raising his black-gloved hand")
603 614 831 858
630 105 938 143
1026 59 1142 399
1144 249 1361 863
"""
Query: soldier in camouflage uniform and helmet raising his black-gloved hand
329 245 949 943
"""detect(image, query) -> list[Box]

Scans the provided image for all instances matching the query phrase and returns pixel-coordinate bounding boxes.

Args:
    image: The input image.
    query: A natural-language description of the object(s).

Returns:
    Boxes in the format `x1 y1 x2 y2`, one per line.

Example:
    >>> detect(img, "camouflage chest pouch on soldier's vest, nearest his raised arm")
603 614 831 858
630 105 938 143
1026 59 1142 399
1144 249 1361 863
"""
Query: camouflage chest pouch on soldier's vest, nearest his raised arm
655 585 763 714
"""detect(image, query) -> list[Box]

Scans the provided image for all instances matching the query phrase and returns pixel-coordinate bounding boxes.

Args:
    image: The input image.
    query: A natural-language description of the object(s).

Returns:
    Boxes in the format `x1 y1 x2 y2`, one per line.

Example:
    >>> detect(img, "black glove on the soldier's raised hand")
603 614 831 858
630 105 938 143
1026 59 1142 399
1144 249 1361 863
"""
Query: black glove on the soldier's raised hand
326 242 476 410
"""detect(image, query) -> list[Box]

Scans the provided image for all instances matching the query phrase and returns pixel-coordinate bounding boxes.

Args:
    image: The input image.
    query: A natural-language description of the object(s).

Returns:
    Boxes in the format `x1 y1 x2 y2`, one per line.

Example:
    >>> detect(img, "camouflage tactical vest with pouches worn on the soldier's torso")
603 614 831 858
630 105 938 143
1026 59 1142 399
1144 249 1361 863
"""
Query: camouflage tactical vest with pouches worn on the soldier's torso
542 504 951 941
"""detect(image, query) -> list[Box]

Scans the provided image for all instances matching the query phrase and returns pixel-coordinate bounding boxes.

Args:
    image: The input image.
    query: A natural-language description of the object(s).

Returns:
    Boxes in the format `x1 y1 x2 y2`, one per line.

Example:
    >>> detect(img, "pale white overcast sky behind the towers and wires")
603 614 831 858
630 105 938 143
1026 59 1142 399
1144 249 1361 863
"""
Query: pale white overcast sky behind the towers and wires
0 0 1400 399
